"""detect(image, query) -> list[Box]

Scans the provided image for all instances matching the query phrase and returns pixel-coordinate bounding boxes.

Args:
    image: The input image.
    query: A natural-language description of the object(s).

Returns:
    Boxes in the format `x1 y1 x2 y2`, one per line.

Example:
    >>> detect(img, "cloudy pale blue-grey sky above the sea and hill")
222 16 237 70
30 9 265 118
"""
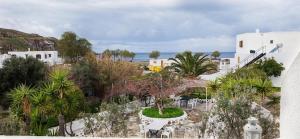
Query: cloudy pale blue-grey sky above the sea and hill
0 0 300 52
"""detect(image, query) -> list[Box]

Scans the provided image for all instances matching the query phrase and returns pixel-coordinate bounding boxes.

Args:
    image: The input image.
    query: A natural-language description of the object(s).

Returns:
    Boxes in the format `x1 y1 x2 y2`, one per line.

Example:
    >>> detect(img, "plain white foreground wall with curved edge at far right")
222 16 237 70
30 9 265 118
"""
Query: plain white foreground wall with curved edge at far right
280 53 300 139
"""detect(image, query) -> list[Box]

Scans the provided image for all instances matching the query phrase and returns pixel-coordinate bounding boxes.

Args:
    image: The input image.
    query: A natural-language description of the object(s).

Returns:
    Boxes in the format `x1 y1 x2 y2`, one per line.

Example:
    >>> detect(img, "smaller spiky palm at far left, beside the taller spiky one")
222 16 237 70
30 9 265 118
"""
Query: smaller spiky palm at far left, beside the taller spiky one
9 84 35 134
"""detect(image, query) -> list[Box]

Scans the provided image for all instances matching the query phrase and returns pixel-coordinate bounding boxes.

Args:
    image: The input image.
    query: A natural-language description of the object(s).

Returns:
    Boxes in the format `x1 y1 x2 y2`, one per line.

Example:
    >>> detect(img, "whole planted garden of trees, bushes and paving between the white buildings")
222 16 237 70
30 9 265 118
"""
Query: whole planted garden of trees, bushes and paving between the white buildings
0 32 284 139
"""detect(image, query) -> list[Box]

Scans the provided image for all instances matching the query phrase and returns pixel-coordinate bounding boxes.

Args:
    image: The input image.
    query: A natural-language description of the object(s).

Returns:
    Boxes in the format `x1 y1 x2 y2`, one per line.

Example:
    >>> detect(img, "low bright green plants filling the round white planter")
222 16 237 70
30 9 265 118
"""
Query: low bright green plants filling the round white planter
143 108 184 118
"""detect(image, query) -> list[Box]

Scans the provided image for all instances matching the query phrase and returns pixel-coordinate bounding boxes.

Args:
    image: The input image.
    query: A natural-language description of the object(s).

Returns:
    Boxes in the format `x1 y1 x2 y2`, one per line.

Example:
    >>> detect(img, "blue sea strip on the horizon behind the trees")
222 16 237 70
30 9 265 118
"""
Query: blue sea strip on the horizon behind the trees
133 52 235 62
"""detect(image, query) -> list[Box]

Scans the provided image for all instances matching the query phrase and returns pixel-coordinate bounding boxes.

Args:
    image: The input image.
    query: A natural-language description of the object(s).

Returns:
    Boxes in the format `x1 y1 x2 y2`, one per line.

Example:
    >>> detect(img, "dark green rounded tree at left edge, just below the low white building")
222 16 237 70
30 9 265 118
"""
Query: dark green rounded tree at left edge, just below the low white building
0 57 48 107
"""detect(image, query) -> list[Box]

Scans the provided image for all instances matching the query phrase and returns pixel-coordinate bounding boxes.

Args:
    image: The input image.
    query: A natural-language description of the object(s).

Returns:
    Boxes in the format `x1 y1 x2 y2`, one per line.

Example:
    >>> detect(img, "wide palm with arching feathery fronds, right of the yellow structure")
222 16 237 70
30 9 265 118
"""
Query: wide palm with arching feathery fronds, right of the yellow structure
170 51 217 77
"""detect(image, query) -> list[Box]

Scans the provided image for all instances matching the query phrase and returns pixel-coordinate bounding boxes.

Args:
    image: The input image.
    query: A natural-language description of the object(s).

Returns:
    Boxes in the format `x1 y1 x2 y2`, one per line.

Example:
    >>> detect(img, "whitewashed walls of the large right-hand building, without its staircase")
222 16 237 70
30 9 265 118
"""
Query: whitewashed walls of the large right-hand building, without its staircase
235 32 300 86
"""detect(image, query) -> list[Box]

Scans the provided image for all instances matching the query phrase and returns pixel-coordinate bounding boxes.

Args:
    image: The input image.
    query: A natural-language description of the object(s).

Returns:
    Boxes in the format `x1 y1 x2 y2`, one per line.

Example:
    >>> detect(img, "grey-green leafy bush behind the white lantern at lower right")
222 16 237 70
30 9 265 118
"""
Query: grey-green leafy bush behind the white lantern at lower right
203 95 279 139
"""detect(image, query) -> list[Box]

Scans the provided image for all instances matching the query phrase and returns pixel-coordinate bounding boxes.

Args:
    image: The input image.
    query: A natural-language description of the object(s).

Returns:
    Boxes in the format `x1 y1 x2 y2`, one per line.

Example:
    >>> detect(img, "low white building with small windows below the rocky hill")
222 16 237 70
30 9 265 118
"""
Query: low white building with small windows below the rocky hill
0 50 62 68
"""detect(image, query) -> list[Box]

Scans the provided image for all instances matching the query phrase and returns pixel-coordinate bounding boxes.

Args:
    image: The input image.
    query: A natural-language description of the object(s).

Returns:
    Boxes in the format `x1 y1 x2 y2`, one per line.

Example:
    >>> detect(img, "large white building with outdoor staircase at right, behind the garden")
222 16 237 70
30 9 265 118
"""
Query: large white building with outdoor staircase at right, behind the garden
203 31 300 86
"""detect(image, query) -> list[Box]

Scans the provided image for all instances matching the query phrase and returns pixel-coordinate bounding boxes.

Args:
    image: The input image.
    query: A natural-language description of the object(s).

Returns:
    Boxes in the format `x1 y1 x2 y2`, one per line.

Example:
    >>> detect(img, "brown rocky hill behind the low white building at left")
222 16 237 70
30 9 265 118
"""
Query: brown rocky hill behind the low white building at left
0 28 57 53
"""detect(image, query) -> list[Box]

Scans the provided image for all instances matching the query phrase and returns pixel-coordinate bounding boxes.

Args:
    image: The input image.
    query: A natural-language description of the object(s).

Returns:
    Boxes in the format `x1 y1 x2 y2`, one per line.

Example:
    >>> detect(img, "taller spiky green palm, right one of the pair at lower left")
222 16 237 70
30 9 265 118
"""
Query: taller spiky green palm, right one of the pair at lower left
43 69 84 136
